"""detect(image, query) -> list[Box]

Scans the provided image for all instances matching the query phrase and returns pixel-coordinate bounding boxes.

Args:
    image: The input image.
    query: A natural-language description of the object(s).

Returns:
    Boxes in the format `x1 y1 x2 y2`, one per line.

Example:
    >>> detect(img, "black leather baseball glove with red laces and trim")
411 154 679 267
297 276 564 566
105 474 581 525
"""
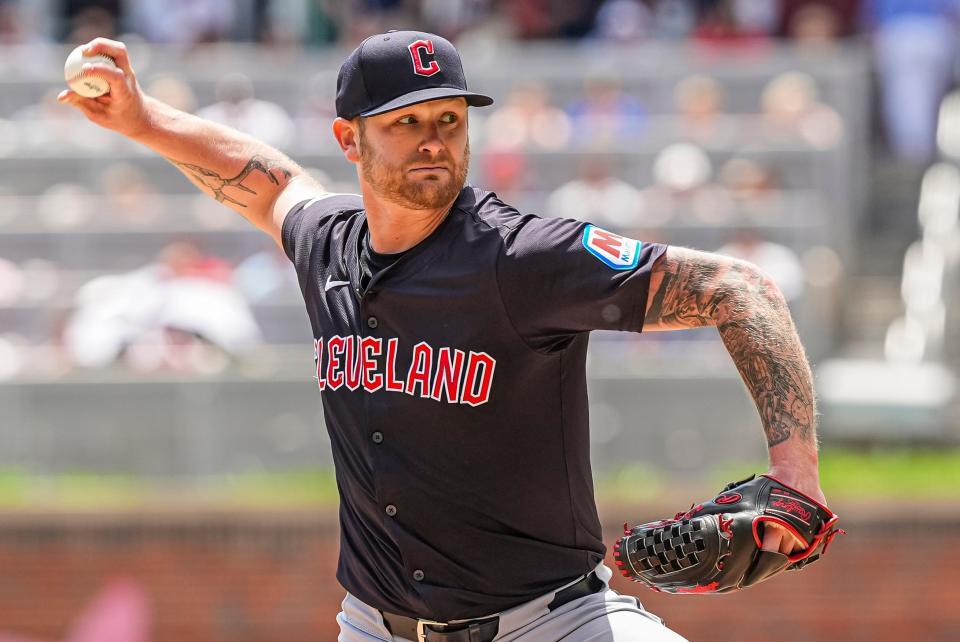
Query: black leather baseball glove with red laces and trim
613 475 844 593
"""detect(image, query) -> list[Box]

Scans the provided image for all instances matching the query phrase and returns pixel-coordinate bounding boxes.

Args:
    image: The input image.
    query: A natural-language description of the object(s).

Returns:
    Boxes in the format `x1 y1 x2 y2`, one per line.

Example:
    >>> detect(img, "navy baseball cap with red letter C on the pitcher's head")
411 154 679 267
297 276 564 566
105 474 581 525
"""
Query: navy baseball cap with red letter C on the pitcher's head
336 31 493 120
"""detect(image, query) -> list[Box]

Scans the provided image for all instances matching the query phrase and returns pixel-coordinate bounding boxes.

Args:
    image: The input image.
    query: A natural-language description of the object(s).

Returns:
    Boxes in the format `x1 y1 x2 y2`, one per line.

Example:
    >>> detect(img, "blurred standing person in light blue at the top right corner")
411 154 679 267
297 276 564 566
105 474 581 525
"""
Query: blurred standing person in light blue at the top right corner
866 0 960 163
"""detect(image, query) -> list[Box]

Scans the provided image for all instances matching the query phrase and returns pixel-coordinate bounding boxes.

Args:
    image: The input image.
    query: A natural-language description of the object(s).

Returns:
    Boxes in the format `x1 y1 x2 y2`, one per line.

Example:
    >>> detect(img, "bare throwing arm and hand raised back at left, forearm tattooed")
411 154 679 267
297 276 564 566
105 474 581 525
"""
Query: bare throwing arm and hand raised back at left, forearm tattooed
58 38 323 244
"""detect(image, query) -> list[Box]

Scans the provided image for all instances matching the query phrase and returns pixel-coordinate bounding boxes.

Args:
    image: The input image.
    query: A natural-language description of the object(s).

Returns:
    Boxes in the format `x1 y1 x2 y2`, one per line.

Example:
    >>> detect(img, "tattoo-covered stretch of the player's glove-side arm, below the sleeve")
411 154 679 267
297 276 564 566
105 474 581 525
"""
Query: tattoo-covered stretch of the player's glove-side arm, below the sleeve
644 247 816 448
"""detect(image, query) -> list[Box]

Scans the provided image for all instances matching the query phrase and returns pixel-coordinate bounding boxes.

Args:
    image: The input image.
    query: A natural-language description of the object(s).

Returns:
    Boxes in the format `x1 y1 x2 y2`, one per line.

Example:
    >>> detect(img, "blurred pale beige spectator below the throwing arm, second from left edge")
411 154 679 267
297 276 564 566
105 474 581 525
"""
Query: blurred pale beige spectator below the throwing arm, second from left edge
100 163 165 226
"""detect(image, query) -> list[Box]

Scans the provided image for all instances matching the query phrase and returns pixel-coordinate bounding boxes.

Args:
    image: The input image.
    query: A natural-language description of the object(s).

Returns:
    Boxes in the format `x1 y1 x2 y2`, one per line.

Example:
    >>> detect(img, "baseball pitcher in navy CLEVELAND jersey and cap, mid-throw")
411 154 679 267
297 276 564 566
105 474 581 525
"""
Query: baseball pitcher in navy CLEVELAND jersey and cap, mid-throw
59 31 823 642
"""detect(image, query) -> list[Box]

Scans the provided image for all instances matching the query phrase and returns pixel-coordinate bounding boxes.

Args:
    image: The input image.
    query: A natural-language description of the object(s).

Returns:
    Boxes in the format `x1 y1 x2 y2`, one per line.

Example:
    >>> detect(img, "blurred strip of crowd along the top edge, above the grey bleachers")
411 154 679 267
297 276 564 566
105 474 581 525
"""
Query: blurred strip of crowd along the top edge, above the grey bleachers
0 0 956 46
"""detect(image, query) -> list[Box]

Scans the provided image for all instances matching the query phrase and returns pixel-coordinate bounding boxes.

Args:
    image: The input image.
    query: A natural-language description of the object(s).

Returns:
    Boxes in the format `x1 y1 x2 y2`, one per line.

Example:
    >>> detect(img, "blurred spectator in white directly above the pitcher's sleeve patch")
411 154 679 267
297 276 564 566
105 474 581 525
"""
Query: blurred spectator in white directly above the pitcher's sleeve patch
547 156 645 234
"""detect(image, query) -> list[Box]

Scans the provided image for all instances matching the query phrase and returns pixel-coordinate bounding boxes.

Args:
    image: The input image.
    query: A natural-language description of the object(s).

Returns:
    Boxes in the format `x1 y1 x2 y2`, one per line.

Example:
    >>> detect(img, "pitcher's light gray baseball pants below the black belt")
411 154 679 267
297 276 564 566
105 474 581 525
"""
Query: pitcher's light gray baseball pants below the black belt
337 564 687 642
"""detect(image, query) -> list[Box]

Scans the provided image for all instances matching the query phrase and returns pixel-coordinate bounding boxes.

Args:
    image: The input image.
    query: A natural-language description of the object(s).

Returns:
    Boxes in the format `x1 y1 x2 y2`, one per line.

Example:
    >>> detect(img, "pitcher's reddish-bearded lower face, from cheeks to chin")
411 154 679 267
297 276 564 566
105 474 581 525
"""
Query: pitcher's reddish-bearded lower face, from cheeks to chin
360 109 470 209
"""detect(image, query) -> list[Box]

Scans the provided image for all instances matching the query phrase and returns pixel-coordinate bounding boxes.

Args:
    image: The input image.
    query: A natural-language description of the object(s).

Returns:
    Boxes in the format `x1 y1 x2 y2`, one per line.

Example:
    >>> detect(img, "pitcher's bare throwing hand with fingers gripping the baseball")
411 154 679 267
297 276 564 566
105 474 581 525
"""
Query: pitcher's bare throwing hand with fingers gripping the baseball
57 38 144 135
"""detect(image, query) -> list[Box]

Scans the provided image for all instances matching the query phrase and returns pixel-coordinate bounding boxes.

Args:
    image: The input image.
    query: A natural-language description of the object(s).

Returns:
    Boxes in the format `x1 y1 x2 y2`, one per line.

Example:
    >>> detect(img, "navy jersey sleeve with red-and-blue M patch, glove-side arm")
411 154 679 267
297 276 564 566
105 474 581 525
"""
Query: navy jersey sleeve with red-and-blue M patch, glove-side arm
497 216 667 349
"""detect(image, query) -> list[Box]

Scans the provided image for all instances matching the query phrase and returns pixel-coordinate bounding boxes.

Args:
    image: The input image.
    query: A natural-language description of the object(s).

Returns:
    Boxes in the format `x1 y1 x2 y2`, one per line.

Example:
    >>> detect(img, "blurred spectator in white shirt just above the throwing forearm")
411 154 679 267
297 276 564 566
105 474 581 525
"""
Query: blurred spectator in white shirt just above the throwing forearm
197 73 295 148
